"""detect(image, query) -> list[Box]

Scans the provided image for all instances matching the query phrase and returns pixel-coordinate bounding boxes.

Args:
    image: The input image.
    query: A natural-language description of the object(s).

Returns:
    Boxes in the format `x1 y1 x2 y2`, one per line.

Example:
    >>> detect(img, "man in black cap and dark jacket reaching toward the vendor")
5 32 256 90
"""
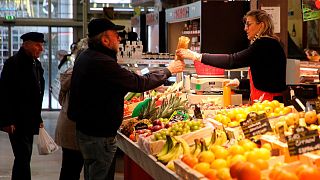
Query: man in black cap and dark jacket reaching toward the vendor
68 18 185 180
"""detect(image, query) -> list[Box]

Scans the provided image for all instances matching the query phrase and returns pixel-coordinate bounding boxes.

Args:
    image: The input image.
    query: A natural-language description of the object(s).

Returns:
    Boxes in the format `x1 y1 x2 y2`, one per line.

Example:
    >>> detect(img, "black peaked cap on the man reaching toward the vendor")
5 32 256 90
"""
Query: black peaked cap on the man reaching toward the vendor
88 18 125 37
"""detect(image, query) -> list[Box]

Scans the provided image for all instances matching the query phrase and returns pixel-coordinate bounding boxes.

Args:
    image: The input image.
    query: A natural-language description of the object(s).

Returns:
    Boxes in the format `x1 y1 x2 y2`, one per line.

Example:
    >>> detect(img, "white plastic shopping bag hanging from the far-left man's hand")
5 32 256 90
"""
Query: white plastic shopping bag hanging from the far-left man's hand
38 128 59 155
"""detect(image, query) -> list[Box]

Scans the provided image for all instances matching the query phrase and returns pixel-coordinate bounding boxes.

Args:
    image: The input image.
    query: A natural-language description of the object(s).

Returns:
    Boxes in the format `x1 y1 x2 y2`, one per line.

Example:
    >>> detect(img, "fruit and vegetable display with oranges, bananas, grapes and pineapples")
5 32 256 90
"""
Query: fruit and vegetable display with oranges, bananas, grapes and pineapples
120 85 320 180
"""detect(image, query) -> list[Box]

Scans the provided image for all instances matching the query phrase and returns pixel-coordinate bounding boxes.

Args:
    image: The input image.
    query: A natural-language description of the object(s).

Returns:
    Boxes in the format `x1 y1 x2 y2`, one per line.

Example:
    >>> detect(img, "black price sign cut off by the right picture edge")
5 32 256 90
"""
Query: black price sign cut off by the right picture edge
286 126 320 156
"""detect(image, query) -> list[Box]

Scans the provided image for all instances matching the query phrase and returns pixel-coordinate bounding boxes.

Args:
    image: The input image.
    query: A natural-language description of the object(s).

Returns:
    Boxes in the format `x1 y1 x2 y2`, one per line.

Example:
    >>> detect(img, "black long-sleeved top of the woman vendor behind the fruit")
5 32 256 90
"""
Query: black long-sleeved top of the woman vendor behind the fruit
201 37 287 92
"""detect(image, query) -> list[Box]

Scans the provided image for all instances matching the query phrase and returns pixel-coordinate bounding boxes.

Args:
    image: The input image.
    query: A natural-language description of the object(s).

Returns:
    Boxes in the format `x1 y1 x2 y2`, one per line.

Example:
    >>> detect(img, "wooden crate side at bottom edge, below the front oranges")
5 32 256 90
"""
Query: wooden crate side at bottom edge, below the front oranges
173 159 208 180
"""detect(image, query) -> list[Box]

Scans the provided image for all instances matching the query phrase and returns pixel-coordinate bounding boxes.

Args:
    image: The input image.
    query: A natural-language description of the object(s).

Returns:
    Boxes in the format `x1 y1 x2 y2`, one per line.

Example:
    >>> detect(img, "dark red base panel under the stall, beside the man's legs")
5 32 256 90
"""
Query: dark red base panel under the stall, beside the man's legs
123 154 153 180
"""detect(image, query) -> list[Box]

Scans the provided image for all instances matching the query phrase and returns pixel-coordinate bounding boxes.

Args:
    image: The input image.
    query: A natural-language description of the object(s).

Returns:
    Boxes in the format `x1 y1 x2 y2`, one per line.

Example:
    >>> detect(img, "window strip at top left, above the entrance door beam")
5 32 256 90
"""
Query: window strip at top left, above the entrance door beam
0 0 73 18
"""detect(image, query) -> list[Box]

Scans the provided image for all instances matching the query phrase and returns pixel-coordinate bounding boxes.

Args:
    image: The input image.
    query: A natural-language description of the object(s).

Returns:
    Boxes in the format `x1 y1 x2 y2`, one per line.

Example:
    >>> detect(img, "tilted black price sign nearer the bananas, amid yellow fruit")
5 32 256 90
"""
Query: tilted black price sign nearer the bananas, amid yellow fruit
240 112 272 139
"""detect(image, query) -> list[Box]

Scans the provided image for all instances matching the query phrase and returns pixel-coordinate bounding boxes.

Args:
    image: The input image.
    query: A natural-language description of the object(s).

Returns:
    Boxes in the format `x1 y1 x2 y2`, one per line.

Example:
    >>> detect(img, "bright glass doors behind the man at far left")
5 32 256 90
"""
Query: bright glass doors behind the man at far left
0 26 73 109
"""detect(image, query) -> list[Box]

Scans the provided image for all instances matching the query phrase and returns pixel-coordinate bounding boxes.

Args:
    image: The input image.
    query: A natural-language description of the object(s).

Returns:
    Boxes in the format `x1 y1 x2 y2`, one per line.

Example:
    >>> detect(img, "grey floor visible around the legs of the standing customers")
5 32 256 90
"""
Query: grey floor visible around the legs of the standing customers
0 112 123 180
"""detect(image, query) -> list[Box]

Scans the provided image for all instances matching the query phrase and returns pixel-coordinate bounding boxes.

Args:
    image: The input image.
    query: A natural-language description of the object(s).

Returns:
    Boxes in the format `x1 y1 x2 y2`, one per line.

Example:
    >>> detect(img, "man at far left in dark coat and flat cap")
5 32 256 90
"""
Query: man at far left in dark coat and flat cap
0 32 45 180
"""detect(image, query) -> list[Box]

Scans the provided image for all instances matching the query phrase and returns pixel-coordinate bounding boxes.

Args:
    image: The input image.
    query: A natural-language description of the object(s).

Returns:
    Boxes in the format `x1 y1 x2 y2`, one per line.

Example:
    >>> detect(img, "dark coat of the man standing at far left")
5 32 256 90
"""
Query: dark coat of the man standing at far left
0 48 44 134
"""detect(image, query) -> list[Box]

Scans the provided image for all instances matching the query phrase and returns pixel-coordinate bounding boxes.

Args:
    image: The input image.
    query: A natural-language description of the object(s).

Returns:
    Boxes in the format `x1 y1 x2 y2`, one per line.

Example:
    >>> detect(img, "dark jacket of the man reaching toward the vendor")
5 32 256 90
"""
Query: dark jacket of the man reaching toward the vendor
68 45 171 137
